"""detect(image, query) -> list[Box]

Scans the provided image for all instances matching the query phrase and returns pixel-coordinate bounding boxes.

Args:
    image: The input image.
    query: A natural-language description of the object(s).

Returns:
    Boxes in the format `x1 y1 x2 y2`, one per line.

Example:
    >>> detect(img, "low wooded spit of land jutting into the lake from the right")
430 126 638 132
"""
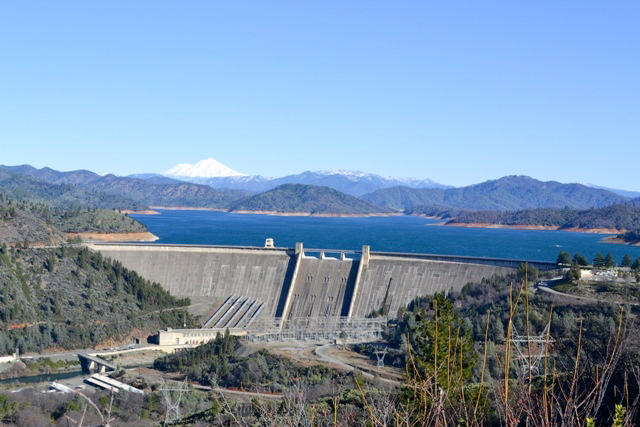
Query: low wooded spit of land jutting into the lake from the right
438 205 640 230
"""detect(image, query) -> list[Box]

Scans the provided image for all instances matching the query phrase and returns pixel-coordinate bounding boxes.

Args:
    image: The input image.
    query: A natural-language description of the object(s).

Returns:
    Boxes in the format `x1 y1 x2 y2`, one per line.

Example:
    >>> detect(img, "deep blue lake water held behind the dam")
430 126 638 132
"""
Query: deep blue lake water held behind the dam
131 210 640 263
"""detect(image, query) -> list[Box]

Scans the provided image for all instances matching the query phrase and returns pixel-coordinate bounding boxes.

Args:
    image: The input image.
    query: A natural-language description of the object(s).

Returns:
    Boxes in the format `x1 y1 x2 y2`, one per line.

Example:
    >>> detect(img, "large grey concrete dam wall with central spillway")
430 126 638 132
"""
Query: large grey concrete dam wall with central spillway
89 243 556 327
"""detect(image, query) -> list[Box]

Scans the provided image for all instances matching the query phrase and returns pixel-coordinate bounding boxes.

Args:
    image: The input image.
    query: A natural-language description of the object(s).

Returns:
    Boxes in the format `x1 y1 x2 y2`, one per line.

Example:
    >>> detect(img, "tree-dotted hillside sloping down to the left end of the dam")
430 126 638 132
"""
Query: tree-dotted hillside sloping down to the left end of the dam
0 245 193 354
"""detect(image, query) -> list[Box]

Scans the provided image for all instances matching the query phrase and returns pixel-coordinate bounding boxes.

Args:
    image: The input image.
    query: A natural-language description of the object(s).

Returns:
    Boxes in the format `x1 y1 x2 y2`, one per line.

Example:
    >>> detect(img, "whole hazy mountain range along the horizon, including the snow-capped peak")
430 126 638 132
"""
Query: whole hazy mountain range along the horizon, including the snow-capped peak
0 162 640 215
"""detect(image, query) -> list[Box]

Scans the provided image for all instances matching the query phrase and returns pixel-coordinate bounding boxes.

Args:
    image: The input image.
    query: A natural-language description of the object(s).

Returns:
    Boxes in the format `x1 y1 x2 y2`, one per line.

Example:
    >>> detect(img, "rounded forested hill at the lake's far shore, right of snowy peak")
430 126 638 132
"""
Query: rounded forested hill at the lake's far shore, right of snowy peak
231 184 390 215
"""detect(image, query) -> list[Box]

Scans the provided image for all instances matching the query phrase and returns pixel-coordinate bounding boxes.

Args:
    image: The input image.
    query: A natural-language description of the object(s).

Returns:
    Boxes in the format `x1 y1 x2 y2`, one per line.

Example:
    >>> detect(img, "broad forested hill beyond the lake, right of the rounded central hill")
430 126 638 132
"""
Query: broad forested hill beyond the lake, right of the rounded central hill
362 176 629 211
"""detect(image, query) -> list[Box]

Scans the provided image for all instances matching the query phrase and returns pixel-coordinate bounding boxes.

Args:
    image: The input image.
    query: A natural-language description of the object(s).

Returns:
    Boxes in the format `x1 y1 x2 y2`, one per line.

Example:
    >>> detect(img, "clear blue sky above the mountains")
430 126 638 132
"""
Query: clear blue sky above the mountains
0 0 640 190
